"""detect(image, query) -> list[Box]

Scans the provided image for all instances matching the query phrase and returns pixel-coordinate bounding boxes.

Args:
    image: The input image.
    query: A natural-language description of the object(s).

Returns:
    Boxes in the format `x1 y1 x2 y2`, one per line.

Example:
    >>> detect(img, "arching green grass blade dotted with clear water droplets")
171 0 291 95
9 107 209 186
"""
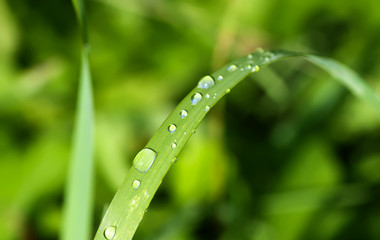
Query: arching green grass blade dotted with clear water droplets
95 50 380 240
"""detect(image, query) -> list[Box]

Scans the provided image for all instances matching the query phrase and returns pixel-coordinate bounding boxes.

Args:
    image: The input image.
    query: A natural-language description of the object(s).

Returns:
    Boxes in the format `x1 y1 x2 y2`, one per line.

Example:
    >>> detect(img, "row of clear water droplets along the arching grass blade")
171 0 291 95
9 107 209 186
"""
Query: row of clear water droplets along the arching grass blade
104 51 269 240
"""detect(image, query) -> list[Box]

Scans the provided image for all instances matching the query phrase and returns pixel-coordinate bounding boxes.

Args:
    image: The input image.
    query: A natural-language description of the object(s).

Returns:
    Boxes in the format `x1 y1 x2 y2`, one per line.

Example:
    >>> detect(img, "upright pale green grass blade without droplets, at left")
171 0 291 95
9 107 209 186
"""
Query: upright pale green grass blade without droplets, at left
61 0 94 240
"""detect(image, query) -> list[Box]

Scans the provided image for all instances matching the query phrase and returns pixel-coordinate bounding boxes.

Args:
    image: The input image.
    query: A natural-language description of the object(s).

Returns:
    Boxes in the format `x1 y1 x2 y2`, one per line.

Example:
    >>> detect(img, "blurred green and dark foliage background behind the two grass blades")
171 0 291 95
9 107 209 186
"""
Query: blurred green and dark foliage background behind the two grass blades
0 0 380 240
